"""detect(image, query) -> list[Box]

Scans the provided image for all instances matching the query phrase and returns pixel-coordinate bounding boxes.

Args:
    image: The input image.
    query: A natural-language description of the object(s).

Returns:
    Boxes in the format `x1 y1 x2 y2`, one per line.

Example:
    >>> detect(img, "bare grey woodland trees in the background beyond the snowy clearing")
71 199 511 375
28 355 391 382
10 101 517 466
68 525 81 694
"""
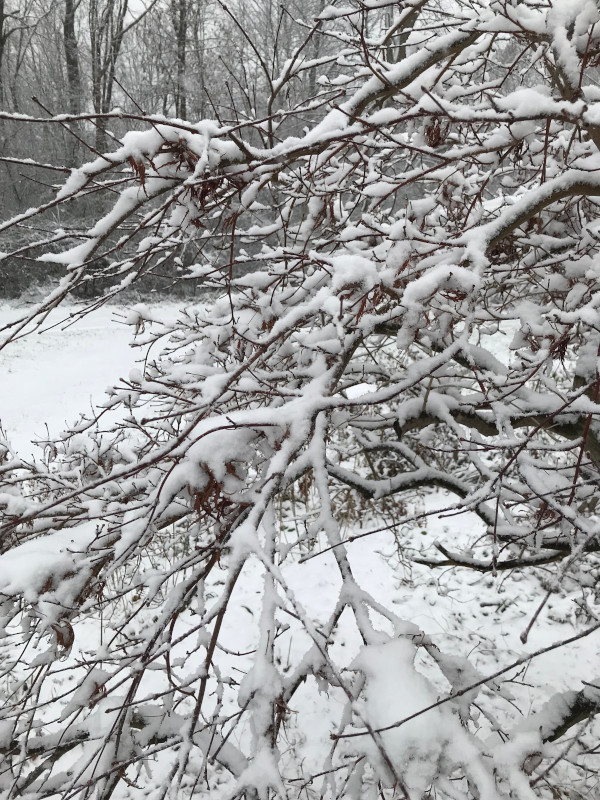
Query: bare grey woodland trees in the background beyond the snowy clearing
0 0 328 213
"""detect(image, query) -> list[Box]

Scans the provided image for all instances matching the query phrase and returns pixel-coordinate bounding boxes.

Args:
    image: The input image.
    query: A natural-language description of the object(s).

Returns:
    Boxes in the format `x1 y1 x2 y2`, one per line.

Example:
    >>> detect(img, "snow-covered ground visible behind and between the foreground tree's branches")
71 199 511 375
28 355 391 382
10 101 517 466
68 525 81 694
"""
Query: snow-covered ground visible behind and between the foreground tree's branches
0 304 599 798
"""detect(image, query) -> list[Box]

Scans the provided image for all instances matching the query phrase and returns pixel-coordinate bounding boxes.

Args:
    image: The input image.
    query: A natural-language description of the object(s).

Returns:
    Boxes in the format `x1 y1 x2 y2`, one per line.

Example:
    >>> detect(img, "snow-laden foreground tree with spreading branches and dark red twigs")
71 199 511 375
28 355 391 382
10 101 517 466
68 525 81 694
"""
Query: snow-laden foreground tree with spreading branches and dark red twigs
0 0 600 800
